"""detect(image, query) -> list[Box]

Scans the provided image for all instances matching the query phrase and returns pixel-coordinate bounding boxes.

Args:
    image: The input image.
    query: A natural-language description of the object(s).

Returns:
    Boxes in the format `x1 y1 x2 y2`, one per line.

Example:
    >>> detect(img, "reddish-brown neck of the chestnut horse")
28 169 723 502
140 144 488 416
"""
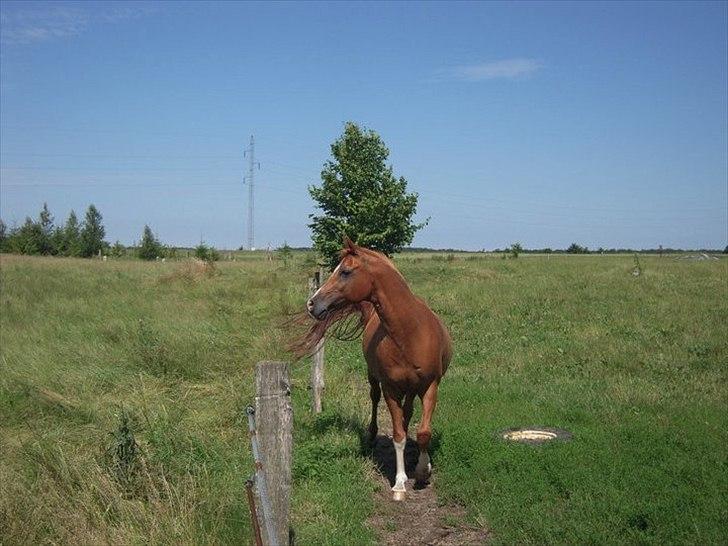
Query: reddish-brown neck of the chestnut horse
371 266 417 348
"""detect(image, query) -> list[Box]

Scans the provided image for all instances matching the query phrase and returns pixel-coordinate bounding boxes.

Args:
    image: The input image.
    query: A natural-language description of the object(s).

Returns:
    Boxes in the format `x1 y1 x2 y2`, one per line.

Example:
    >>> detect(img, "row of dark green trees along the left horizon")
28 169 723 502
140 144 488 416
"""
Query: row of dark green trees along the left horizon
0 203 220 261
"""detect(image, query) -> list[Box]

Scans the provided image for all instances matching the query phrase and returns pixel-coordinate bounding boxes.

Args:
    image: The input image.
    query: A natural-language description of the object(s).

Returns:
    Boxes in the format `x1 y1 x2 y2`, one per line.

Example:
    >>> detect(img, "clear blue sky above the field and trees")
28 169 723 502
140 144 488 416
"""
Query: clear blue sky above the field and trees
0 1 728 249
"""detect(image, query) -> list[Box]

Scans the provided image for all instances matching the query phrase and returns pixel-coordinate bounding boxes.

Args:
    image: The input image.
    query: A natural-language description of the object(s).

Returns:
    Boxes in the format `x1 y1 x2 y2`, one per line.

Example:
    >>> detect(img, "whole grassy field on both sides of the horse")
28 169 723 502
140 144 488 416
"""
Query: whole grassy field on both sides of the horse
0 255 728 545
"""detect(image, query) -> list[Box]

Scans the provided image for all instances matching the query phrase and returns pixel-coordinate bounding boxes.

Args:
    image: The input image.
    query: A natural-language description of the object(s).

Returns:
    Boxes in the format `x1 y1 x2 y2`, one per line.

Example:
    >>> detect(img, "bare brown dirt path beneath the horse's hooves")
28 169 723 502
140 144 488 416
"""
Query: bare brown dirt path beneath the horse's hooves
369 412 488 546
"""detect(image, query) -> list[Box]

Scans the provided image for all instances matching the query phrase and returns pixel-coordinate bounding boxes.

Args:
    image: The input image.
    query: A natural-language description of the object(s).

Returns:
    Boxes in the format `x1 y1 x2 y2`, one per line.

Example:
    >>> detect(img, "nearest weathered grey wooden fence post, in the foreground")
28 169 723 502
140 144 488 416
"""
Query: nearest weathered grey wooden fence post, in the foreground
255 361 293 546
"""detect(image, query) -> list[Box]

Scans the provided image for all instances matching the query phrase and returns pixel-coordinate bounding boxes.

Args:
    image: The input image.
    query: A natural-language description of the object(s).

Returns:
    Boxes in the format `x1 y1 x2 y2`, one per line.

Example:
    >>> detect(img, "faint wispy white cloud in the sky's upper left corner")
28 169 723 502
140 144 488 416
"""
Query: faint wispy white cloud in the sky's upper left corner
0 4 154 45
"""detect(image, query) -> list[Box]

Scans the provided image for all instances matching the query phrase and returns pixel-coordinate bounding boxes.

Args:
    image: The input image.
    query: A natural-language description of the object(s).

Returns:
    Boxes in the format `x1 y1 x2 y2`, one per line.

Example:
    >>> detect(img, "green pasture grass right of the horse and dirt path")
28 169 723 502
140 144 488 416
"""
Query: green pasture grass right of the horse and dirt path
403 256 728 544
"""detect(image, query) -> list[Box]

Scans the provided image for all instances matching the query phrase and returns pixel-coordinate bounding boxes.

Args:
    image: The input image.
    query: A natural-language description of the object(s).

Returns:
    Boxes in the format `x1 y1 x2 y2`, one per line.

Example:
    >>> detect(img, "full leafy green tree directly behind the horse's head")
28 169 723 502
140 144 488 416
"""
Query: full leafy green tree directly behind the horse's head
309 122 427 266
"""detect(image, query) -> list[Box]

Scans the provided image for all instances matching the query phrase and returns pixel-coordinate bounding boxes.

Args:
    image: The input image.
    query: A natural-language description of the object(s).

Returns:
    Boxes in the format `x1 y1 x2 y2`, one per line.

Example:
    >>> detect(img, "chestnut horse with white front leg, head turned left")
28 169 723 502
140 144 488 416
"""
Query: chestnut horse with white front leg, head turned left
307 238 452 500
